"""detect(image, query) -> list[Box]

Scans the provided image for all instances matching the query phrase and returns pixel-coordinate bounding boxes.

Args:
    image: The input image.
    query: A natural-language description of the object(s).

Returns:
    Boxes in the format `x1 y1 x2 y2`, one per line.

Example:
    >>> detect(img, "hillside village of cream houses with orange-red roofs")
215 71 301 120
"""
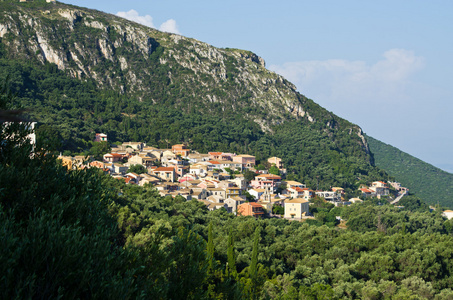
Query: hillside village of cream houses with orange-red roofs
58 133 408 220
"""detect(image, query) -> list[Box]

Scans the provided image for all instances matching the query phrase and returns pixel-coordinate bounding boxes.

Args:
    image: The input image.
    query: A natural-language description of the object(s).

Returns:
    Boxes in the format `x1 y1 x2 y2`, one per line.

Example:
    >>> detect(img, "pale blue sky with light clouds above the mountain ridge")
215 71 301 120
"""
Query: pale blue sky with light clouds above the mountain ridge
61 0 453 173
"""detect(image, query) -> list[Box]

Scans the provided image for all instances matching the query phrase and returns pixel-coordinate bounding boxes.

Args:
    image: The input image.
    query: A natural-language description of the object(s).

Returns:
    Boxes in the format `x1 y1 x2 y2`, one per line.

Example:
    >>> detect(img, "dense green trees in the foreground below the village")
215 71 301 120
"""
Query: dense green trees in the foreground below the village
0 93 453 300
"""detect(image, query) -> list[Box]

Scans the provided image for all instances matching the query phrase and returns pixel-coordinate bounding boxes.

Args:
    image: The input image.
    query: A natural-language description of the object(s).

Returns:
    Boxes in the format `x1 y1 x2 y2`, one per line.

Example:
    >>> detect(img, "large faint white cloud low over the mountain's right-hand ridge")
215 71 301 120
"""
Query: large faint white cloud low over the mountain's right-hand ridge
270 49 424 107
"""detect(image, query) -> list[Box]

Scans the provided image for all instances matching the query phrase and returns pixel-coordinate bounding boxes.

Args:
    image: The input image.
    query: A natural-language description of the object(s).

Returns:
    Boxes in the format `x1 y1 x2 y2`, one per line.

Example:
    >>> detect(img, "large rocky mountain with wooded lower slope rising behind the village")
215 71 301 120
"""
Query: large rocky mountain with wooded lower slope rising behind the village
0 1 388 192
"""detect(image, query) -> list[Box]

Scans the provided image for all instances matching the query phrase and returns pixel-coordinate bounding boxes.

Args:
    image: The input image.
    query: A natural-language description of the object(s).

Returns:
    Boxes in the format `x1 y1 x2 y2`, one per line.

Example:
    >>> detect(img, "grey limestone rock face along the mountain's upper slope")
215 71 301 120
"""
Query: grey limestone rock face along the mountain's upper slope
0 3 368 149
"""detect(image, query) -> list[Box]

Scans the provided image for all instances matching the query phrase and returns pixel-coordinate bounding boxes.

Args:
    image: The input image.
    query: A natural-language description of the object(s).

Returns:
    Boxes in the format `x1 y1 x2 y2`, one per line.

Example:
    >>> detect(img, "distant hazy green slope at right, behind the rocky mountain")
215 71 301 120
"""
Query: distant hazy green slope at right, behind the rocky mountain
367 136 453 207
